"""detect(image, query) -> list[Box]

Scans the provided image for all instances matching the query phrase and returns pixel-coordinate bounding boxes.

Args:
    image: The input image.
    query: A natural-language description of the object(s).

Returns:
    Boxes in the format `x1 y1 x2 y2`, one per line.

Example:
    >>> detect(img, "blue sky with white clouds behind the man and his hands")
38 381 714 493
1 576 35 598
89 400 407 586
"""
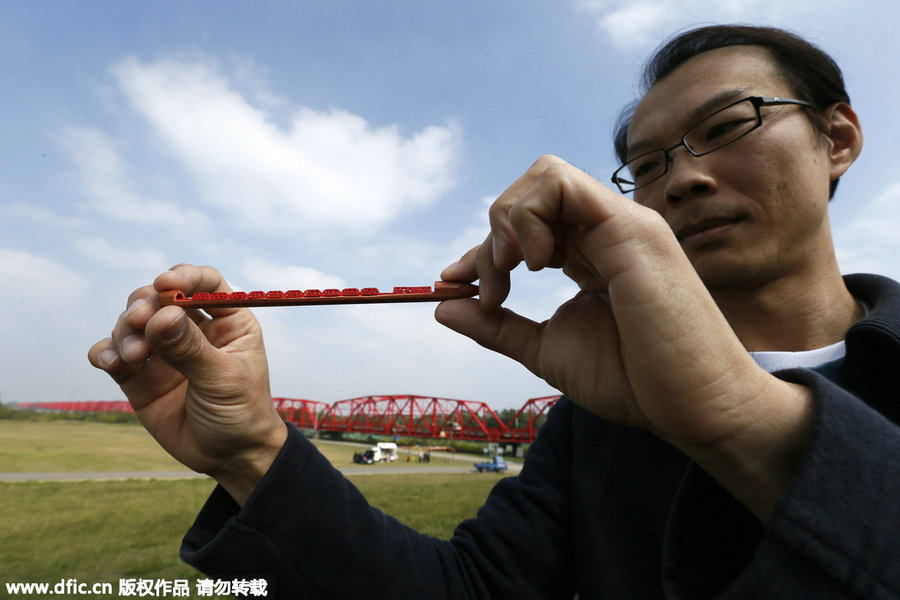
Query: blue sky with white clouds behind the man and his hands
0 0 900 408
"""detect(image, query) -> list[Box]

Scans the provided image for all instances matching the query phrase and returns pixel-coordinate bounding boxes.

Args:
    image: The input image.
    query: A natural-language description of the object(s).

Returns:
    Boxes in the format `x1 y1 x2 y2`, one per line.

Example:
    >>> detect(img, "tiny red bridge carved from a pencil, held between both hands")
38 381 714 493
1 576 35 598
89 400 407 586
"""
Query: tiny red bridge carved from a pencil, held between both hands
159 281 478 308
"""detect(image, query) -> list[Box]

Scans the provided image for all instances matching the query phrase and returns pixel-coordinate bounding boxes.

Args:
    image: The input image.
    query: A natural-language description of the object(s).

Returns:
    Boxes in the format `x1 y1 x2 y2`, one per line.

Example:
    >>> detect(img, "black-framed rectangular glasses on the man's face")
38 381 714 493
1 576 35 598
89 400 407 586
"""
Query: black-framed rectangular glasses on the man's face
612 96 812 194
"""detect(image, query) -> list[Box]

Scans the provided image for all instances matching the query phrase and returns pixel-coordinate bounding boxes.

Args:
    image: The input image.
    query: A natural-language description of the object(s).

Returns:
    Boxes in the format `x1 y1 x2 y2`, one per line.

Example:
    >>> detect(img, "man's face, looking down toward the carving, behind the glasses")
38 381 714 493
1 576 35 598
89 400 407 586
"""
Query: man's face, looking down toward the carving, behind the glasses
628 46 832 291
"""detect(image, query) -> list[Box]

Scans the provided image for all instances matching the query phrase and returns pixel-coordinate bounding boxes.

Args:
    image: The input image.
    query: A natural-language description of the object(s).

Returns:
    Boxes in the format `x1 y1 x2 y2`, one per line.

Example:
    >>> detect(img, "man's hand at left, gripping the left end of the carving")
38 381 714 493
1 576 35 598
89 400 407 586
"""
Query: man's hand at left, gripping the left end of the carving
88 265 287 504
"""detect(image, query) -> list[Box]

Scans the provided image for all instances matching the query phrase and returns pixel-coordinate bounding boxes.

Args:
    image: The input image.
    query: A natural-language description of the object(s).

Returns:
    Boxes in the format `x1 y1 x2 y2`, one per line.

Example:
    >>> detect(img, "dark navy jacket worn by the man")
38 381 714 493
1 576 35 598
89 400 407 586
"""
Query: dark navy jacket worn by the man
181 275 900 600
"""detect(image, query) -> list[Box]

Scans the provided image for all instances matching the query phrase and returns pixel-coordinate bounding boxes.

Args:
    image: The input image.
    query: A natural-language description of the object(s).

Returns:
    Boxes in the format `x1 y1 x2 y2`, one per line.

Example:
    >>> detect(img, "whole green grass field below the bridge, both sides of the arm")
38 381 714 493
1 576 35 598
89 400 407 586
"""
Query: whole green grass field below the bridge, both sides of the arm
0 419 506 598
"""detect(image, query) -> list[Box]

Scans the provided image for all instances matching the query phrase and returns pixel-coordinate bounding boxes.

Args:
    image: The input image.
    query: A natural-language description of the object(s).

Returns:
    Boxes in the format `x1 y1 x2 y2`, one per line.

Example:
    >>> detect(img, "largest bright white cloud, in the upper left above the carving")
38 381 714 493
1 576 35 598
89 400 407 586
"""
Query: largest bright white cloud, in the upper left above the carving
113 58 461 235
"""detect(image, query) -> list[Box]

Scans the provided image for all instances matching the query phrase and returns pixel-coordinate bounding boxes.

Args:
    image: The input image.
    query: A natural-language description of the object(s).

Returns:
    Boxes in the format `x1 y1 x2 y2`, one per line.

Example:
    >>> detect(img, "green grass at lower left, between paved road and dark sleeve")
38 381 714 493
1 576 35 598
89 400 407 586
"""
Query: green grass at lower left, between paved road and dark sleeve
0 479 213 582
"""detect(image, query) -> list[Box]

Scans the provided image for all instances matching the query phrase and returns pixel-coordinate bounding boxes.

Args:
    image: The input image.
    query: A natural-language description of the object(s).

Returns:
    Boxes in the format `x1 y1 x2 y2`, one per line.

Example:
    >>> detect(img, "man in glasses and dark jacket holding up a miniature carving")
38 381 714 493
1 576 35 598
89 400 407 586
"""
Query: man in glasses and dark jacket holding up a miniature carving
90 27 900 599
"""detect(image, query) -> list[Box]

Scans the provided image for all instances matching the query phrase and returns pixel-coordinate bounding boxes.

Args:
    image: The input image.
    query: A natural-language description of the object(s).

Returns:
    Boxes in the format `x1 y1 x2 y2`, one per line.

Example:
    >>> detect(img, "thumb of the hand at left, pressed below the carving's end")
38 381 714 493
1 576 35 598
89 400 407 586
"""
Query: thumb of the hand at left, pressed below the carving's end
144 306 222 385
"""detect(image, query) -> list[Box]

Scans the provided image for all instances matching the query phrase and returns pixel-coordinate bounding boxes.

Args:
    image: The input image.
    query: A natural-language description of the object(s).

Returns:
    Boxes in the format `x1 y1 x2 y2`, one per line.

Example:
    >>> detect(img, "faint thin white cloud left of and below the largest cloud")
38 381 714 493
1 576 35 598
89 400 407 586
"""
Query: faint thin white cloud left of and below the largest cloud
59 126 206 225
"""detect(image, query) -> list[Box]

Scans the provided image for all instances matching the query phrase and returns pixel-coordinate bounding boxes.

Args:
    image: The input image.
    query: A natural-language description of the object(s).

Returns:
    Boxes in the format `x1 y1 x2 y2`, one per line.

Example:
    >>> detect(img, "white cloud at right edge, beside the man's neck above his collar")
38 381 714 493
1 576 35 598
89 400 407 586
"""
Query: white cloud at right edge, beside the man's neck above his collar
835 182 900 280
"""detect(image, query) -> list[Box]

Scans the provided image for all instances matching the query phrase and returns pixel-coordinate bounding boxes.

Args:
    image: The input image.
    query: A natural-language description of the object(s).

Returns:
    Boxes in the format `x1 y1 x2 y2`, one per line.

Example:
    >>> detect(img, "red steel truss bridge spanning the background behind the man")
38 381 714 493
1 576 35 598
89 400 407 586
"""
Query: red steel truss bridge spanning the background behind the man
18 395 559 444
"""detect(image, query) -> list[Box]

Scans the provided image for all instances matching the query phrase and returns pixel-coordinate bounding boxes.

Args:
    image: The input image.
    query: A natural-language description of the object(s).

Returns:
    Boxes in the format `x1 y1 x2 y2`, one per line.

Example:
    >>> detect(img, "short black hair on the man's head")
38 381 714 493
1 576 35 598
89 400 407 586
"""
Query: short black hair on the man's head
614 25 850 196
